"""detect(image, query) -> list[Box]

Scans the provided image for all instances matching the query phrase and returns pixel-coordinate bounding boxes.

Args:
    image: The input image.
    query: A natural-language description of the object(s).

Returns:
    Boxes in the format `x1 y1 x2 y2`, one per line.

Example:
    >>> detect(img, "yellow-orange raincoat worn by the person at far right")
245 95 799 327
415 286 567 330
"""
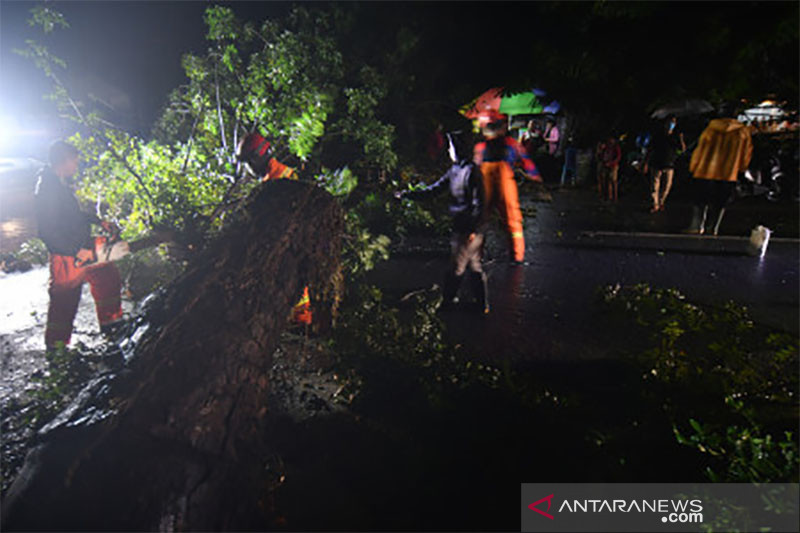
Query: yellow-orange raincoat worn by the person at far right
689 118 753 181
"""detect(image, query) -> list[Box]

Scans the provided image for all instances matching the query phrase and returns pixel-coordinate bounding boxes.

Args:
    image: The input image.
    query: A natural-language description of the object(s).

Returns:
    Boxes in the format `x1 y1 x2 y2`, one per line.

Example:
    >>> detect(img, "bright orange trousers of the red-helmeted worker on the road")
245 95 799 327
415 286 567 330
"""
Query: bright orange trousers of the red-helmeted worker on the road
481 161 525 261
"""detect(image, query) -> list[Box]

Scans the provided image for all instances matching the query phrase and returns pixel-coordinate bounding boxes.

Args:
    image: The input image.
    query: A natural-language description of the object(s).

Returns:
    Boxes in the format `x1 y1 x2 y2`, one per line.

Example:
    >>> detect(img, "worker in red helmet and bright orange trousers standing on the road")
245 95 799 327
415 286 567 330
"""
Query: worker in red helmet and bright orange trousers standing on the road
475 111 542 264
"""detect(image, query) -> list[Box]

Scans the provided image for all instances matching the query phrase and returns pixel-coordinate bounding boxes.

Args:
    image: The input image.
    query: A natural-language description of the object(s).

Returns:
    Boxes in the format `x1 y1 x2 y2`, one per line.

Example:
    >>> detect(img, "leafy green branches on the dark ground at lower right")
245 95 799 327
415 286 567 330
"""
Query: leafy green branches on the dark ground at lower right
601 285 800 482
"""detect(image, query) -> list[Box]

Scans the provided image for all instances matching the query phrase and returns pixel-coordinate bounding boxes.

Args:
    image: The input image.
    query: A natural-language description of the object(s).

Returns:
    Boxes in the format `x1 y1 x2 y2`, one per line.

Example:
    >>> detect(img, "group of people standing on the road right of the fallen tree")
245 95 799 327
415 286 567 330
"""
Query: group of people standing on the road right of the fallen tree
404 101 791 312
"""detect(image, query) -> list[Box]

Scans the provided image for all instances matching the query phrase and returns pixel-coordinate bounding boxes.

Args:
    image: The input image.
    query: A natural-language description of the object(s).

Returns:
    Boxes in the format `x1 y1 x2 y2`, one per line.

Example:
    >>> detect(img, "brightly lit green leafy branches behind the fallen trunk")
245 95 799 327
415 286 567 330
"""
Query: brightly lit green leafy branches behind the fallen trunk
21 6 397 243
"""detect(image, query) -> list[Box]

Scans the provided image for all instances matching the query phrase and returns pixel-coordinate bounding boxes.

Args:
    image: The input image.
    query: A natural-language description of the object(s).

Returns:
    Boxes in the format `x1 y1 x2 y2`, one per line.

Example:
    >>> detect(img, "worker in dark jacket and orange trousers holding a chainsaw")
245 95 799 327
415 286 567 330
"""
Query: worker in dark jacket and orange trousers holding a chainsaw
35 141 122 350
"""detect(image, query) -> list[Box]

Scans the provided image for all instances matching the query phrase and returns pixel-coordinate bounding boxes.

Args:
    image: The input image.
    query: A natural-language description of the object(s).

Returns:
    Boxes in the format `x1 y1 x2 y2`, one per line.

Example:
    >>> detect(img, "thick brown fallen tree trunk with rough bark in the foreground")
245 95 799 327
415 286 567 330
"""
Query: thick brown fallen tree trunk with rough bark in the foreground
2 180 343 531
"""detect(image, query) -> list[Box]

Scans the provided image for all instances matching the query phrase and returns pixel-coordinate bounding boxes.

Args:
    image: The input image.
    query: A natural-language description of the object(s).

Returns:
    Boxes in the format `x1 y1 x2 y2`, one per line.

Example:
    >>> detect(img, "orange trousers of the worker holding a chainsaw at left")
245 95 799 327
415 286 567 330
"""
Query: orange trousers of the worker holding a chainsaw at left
44 243 122 348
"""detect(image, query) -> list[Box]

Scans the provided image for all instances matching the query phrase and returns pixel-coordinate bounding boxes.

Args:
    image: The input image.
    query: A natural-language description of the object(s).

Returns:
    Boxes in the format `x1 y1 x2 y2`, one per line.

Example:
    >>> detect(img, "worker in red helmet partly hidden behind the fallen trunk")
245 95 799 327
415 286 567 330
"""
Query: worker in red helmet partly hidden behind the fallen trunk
236 132 312 325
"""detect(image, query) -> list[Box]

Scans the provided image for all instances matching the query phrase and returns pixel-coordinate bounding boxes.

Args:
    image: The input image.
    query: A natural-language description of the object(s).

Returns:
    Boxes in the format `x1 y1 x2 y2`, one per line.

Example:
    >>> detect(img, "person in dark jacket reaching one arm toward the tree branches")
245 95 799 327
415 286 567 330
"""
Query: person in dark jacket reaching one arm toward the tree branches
395 133 489 314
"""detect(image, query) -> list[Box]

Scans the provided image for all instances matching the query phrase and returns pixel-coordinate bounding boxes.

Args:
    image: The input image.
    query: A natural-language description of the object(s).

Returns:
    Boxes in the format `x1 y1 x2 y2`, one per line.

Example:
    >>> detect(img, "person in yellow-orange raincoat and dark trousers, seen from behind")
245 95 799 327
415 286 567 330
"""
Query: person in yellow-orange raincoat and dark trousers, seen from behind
686 109 753 236
